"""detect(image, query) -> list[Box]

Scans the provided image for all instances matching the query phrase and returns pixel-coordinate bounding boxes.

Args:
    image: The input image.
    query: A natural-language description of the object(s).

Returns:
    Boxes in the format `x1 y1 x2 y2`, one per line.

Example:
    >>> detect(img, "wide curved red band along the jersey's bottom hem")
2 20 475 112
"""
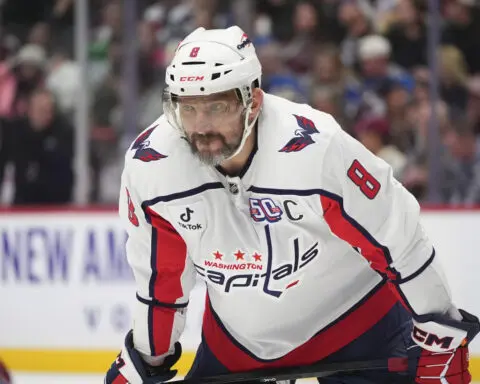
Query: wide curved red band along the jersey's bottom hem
203 284 397 372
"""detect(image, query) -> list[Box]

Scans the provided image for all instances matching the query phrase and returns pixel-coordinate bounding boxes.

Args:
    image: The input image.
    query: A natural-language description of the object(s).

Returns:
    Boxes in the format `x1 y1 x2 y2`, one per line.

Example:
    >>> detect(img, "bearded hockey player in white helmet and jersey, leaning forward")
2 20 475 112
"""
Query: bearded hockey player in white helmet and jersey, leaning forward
105 26 479 384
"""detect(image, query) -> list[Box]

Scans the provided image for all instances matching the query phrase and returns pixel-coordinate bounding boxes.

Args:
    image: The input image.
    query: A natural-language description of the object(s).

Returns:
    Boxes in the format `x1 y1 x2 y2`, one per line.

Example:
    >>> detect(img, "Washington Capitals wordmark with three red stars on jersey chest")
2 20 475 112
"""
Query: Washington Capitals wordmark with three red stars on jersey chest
194 238 320 299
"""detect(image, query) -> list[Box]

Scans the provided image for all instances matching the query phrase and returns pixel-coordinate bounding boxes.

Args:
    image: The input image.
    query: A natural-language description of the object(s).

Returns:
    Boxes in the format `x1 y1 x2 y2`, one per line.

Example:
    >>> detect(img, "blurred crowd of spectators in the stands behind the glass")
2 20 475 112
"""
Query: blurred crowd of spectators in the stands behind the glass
0 0 480 205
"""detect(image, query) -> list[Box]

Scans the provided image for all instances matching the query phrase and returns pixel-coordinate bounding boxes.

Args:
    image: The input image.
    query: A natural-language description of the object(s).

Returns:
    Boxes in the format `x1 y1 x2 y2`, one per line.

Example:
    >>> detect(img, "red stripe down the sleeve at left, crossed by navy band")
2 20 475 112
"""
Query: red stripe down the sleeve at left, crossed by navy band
146 208 187 356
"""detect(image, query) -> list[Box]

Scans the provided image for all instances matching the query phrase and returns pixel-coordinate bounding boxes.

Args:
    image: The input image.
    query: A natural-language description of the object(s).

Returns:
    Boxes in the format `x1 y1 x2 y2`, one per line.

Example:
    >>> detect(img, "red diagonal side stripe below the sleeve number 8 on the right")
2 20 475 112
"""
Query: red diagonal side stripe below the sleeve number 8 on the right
320 195 397 280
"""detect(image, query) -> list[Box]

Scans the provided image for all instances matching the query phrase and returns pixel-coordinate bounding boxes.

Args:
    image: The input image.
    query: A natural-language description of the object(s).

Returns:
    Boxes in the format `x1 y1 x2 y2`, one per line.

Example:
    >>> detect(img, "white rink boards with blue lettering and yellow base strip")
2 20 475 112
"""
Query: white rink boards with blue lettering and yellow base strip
0 210 480 380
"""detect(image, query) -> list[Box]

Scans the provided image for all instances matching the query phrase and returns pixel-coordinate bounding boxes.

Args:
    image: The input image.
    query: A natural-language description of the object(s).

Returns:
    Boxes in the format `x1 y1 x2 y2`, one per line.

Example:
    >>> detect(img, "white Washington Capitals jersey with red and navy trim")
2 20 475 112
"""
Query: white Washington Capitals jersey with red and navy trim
120 94 452 370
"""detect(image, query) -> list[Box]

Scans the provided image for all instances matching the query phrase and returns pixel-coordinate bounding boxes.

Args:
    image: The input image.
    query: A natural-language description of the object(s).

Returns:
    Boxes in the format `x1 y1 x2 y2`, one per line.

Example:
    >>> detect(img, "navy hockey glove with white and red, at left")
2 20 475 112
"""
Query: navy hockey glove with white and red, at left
104 331 182 384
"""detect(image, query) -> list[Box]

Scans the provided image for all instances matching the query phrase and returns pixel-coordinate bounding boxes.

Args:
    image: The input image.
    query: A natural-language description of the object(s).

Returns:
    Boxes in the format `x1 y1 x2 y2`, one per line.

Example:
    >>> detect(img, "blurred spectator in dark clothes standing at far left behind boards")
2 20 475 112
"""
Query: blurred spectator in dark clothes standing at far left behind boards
9 89 74 205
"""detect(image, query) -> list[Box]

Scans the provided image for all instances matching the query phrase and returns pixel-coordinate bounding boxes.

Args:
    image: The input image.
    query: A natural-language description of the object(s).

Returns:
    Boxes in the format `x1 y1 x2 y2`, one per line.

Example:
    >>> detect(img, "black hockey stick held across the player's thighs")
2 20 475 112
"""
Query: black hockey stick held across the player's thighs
172 357 413 384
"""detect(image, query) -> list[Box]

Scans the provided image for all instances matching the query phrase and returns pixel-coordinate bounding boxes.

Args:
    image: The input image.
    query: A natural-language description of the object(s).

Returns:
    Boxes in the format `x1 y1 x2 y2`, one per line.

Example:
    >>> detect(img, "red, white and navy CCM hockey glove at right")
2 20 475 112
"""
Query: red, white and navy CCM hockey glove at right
408 309 480 384
